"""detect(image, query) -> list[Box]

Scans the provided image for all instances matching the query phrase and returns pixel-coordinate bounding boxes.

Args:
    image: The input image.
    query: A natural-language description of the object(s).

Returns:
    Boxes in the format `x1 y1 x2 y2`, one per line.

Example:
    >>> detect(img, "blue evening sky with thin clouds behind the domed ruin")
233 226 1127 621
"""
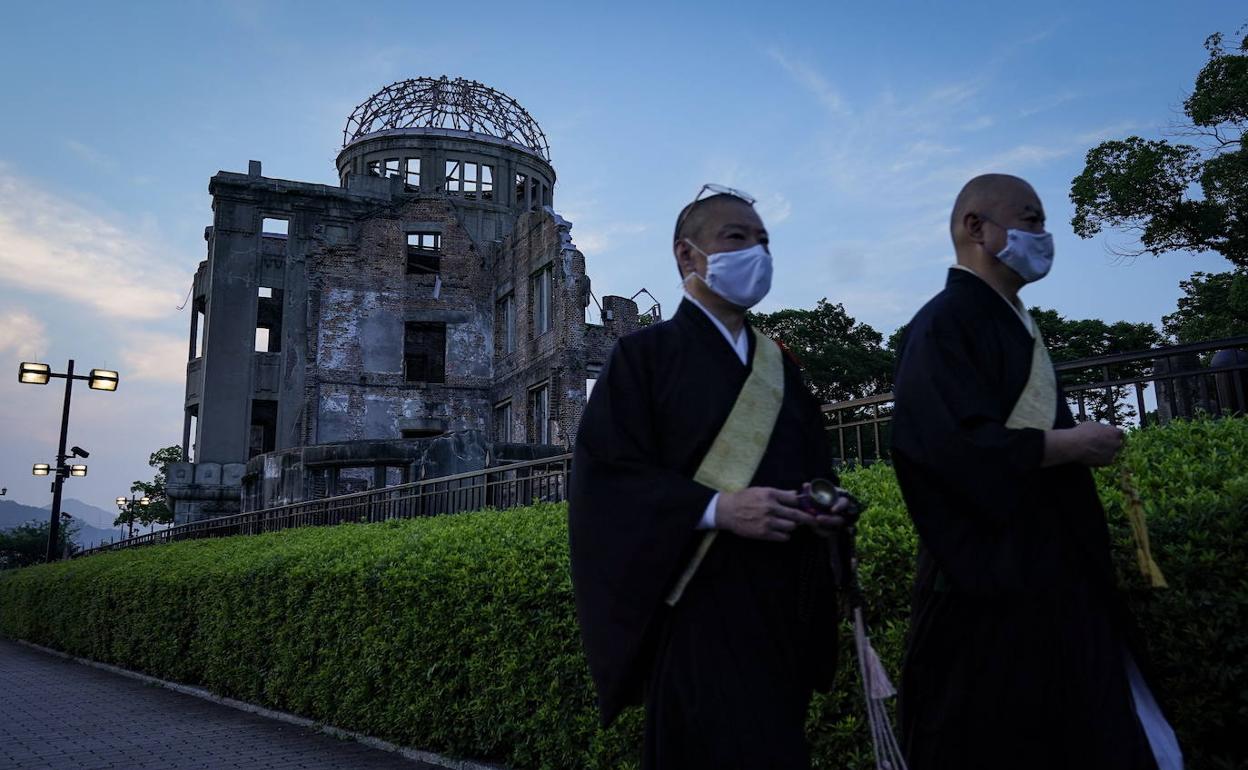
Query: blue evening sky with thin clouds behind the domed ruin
0 0 1248 509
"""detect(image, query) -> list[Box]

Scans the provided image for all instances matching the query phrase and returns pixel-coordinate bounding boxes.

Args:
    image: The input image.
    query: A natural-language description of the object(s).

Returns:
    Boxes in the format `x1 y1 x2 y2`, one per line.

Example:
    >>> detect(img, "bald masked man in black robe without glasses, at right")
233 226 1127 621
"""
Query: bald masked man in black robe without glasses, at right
892 173 1182 770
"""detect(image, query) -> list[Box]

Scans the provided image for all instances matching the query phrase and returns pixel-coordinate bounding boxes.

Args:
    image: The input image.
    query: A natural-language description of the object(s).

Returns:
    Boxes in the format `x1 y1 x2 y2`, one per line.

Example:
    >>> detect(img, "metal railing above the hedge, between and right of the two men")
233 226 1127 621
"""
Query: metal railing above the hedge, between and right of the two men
822 337 1248 465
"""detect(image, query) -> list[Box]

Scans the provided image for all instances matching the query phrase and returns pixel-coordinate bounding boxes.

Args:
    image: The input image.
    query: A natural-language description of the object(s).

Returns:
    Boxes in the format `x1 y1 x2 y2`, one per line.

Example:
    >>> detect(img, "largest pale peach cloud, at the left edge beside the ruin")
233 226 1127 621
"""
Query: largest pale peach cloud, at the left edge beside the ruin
0 165 190 319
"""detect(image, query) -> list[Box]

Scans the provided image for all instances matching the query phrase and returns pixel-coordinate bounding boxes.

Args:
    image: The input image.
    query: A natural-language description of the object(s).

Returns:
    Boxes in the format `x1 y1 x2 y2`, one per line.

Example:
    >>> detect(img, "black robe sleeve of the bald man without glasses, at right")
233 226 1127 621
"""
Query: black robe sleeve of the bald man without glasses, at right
892 315 1045 528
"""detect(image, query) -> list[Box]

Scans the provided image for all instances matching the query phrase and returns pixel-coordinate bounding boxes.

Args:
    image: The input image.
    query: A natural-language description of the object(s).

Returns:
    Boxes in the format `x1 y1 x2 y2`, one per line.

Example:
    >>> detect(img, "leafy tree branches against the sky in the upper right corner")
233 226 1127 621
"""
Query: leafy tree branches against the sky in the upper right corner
1071 25 1248 267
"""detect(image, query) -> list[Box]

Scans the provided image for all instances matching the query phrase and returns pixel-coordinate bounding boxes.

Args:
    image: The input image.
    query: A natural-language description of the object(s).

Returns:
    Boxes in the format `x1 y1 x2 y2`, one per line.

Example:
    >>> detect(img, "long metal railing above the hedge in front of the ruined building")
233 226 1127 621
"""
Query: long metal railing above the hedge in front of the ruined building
75 454 572 557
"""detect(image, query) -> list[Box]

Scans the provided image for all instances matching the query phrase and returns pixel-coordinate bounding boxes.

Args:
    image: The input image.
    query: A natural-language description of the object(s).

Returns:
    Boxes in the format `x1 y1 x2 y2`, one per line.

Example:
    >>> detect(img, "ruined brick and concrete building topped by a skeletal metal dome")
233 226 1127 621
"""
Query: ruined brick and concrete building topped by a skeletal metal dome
168 77 639 522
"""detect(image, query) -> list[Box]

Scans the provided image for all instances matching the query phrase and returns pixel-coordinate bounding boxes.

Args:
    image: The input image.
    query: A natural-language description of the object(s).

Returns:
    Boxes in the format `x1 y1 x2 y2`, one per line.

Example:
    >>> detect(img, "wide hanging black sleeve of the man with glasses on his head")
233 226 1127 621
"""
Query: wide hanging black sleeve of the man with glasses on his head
568 337 715 721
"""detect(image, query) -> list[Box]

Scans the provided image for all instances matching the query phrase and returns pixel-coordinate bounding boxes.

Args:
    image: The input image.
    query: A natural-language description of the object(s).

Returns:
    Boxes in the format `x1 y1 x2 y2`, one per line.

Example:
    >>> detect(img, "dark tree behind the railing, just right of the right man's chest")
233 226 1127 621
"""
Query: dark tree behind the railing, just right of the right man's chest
1031 307 1164 423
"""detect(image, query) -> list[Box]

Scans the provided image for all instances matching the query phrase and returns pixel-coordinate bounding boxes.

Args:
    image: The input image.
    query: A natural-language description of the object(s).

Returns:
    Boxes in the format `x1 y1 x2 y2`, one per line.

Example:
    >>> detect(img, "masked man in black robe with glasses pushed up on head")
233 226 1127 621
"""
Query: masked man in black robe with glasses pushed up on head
569 185 845 770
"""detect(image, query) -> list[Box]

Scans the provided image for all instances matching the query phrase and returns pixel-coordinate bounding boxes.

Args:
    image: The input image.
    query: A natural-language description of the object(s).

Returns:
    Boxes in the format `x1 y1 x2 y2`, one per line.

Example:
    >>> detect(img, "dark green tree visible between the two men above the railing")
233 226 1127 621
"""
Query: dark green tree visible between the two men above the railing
749 298 894 402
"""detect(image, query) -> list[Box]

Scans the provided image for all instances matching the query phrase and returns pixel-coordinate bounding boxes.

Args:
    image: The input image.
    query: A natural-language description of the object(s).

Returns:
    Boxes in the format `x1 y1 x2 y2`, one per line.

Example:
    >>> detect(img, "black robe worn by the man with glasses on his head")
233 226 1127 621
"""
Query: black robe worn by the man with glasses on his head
568 301 837 770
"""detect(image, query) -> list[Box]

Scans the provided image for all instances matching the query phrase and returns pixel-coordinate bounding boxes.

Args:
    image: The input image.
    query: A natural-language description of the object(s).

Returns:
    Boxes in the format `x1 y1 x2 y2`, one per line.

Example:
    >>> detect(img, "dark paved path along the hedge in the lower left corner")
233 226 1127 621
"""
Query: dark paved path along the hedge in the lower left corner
0 639 434 770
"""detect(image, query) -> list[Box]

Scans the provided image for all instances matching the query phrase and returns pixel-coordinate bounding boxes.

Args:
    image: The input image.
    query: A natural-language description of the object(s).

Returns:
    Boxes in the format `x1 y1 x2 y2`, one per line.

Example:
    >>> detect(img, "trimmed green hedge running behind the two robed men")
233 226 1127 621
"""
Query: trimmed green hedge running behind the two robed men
0 419 1248 770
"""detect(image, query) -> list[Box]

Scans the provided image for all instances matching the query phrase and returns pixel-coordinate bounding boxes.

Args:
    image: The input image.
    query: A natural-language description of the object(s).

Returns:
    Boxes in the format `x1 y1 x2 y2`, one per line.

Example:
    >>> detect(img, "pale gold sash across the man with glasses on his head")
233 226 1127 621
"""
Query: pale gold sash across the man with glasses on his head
668 329 784 607
